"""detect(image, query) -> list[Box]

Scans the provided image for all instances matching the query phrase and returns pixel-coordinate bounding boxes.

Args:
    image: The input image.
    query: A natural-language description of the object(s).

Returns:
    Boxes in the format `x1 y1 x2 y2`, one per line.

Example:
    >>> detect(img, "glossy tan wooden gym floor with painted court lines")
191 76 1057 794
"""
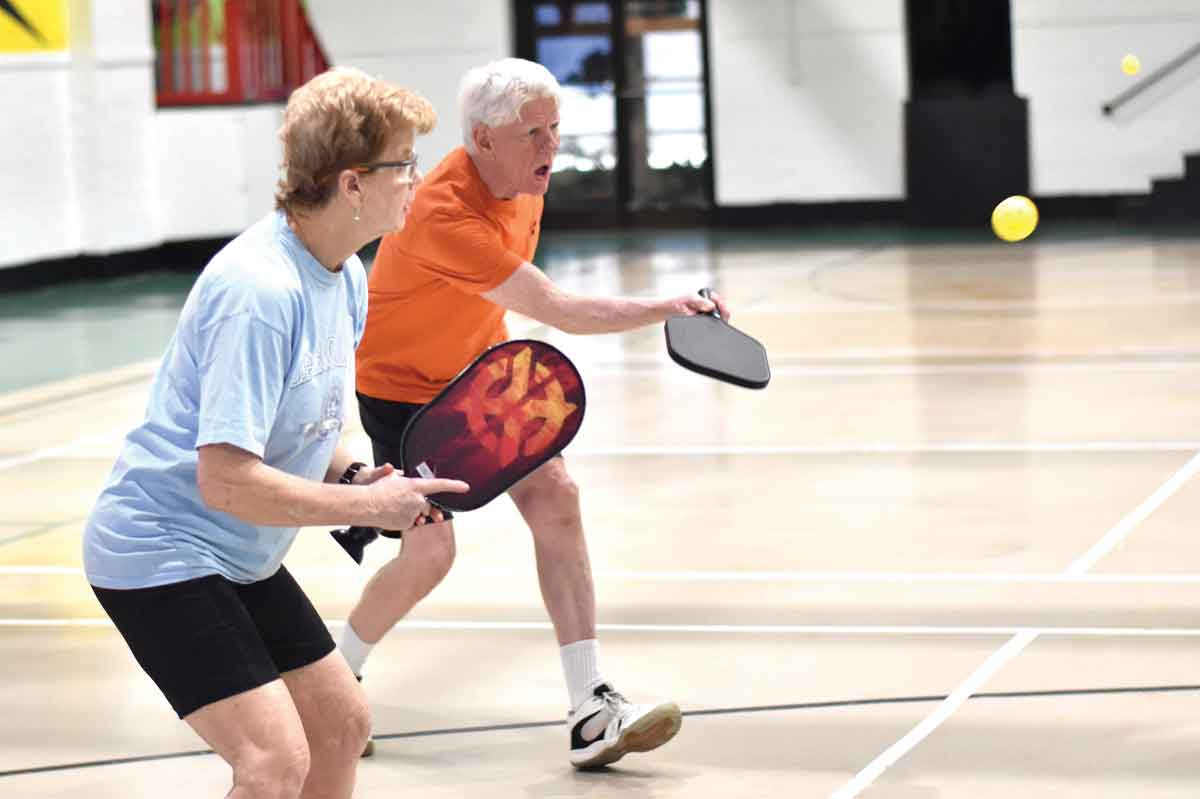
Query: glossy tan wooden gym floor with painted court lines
0 226 1200 799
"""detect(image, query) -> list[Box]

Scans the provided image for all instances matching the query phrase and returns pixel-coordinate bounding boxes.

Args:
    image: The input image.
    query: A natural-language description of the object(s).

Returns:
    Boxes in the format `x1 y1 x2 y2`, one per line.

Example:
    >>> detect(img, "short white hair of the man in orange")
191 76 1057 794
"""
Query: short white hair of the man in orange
458 59 562 155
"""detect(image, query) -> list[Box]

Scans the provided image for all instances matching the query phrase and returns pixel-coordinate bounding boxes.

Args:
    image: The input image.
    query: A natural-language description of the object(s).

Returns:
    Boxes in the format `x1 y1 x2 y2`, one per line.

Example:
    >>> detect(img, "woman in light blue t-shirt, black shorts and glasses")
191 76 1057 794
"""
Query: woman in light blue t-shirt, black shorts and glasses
84 70 467 799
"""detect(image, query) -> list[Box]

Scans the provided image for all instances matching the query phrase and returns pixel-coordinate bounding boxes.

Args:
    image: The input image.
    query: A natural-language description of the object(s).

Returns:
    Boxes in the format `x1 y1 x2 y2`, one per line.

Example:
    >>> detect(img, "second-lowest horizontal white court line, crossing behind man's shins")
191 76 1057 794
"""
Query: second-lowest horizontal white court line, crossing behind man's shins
7 565 1200 585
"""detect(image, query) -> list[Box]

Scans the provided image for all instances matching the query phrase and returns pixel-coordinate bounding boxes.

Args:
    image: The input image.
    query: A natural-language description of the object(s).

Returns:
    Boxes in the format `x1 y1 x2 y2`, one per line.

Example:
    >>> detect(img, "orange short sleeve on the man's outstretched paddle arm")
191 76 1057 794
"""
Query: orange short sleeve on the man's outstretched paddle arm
408 208 524 294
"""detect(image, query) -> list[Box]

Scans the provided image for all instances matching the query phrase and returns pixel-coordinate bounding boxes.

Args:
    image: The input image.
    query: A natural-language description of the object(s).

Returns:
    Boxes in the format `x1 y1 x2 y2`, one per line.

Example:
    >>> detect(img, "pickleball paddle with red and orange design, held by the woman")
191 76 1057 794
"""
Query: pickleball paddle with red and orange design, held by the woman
334 338 587 563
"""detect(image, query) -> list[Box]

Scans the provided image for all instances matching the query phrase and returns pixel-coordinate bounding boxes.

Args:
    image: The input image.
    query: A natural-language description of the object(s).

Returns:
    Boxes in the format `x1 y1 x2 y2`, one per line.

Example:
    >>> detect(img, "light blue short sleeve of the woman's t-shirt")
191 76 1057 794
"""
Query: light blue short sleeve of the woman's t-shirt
196 311 292 457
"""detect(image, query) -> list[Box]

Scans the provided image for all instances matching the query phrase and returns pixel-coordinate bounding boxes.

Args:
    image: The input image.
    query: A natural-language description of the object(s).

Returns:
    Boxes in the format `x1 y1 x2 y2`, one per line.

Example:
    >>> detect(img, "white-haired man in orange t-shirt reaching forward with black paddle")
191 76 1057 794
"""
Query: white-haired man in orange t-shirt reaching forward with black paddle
341 59 728 768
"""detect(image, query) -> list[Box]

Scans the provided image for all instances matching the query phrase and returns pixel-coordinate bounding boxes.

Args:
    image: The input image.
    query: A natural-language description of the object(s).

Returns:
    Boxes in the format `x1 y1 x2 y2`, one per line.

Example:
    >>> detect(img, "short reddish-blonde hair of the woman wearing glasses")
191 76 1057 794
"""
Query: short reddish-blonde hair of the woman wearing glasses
275 67 437 214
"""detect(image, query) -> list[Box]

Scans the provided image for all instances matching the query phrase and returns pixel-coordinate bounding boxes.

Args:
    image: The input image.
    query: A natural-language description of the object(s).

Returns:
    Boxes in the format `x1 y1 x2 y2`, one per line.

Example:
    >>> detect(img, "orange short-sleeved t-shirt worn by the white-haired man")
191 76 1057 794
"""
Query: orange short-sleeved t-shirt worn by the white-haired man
356 148 542 403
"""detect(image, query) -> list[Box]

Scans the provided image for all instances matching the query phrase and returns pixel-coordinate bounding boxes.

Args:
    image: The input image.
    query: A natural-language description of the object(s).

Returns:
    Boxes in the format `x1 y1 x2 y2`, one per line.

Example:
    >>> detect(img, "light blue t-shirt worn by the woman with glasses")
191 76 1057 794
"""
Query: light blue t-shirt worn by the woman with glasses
83 211 367 589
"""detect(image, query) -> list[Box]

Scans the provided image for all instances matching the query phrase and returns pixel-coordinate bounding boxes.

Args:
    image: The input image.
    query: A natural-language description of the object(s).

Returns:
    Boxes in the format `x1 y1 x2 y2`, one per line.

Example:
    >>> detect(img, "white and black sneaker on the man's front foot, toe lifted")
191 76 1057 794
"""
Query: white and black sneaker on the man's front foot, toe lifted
566 684 683 769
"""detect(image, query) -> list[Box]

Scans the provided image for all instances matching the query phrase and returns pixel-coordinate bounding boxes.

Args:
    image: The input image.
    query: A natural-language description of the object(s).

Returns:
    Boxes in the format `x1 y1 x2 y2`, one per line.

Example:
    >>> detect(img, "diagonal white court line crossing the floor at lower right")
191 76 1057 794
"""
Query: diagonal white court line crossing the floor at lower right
832 455 1200 799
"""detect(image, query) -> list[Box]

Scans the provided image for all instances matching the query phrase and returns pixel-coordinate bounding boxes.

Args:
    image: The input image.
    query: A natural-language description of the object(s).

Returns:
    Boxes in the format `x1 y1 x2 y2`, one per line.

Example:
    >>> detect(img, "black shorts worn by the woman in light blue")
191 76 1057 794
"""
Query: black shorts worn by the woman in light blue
92 566 334 719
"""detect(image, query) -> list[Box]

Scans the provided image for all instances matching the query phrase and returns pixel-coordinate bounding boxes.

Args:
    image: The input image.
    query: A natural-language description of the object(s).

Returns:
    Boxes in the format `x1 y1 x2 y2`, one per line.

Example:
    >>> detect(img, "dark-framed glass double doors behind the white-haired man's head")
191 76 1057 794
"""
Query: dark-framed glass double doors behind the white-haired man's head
516 0 713 227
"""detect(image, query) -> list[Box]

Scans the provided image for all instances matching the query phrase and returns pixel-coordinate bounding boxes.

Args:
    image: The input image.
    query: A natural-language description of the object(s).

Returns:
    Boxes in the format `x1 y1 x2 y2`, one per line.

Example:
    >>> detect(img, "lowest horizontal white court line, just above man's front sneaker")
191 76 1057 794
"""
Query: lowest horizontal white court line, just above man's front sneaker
0 618 1200 633
